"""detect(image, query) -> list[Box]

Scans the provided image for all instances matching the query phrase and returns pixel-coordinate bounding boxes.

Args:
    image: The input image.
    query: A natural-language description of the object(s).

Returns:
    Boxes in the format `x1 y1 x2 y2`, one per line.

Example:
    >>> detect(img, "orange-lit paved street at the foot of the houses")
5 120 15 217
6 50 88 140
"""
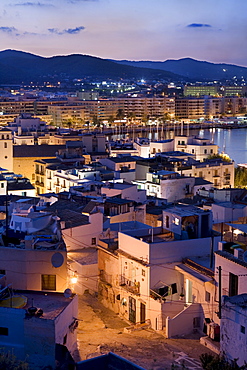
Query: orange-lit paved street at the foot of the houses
73 294 212 370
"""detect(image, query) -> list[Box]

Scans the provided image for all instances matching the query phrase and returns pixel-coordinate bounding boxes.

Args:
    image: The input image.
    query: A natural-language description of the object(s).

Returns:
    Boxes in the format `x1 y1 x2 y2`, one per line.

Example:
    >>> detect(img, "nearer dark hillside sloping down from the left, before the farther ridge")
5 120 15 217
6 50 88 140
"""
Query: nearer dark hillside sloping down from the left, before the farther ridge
0 50 181 84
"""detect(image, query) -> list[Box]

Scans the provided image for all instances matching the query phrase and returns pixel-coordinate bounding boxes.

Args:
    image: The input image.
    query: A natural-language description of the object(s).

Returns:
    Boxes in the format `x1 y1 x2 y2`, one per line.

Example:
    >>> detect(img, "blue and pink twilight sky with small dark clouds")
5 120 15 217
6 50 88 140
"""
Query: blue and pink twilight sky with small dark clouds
0 0 247 66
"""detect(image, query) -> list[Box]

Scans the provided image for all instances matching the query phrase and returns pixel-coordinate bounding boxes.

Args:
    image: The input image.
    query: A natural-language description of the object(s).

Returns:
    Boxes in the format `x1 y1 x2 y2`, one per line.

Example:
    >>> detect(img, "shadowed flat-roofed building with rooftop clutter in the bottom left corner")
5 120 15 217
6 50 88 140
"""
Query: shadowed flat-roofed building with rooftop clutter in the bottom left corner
0 289 78 370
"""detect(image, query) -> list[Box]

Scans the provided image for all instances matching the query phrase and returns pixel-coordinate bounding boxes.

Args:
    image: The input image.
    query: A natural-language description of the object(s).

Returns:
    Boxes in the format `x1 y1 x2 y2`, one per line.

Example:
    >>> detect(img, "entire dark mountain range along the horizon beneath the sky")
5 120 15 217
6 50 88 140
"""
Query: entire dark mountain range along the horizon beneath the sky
0 50 247 84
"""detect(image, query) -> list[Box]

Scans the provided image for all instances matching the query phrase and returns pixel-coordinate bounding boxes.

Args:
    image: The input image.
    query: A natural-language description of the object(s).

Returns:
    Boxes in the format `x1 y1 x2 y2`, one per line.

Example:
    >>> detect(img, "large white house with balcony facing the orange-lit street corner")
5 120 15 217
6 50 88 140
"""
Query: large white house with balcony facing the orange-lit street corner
99 207 219 337
